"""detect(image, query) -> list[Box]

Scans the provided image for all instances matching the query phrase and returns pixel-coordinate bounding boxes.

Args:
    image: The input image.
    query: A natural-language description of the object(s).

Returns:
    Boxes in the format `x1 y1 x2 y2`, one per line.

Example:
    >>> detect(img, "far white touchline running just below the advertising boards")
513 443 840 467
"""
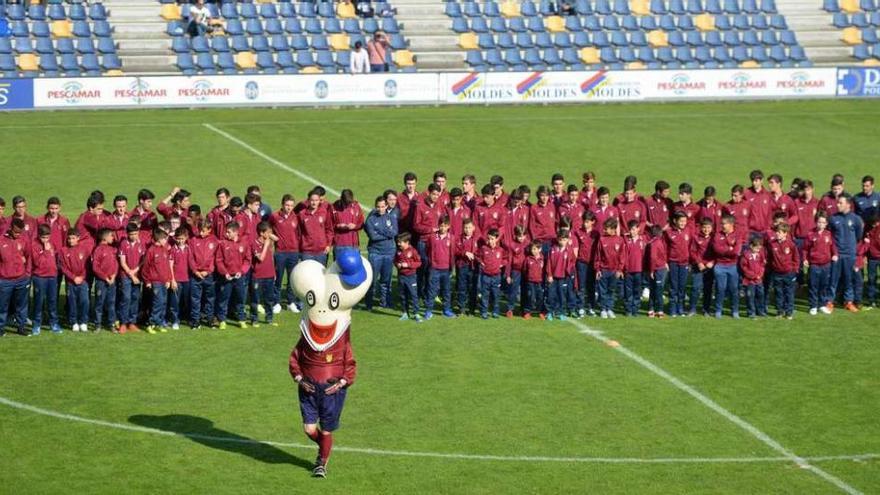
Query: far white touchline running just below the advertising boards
0 111 880 130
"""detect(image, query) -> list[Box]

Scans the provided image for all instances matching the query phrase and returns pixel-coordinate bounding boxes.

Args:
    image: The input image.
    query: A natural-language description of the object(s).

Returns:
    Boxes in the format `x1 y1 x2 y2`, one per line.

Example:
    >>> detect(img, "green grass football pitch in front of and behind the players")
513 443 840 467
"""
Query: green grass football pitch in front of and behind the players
0 100 880 494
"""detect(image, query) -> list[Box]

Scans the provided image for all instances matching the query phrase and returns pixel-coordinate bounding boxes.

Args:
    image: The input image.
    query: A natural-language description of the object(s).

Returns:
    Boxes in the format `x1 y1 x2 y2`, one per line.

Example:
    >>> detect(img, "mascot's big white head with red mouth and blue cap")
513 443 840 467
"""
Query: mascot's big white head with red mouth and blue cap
293 249 373 351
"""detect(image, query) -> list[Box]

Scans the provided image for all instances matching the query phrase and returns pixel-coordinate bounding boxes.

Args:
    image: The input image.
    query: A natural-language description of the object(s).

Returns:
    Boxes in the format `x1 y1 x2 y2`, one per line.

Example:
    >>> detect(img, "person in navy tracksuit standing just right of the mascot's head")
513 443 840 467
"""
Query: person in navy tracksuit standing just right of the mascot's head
364 196 397 311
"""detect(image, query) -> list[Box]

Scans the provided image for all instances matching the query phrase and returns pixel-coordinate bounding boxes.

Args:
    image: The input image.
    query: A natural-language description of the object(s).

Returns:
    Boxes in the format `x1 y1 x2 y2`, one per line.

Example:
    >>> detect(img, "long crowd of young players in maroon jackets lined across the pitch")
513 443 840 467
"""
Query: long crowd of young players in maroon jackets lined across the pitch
0 171 880 338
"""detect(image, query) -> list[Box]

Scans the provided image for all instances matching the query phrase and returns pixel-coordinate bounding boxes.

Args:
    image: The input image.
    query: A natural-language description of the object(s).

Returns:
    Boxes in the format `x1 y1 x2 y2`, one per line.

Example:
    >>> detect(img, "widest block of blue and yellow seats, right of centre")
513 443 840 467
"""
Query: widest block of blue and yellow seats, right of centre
446 0 811 71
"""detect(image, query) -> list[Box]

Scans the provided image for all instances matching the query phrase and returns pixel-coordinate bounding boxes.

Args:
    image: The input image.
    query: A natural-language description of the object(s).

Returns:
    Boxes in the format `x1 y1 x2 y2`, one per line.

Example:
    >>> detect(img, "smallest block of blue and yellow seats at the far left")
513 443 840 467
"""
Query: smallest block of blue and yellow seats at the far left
0 0 122 77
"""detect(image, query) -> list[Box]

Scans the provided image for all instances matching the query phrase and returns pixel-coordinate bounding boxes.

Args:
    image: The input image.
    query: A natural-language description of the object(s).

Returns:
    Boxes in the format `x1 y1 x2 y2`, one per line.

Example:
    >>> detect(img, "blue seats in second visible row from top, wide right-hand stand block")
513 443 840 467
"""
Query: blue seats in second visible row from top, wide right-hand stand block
452 14 788 33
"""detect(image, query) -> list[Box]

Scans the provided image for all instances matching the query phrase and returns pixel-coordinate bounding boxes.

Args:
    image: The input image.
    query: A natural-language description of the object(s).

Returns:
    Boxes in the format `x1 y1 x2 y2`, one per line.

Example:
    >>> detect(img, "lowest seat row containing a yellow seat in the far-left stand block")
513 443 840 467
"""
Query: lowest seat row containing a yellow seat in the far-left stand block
0 54 122 77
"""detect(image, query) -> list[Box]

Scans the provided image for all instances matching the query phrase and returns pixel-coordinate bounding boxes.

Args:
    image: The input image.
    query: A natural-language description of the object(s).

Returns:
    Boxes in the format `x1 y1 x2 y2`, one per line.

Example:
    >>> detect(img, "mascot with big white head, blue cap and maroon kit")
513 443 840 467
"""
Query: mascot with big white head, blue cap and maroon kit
290 249 373 478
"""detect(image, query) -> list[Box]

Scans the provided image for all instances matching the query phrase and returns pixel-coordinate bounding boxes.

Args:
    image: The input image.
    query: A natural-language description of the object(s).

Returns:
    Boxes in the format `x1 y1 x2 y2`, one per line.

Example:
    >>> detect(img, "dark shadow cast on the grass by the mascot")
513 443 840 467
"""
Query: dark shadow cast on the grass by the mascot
128 414 314 470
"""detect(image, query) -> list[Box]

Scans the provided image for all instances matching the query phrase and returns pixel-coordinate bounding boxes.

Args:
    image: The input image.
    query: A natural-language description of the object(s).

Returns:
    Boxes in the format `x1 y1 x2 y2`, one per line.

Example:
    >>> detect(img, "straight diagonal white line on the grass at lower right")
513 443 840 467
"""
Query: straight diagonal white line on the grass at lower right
570 320 862 495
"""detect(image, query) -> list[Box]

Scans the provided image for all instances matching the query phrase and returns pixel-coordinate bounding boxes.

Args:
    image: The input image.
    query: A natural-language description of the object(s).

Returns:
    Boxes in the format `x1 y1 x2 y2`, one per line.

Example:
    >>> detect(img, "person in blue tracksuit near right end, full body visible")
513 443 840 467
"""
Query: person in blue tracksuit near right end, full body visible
828 194 864 313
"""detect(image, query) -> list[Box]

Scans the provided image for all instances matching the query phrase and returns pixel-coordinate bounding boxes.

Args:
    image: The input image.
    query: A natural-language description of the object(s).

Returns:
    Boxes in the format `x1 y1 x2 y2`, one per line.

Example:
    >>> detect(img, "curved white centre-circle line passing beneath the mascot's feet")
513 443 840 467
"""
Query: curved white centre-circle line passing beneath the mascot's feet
0 397 880 464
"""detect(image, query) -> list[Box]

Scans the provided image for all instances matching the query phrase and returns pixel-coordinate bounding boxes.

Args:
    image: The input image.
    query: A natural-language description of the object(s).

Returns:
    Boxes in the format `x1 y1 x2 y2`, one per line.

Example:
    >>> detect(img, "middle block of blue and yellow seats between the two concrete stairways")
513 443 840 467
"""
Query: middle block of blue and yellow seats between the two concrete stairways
161 0 416 75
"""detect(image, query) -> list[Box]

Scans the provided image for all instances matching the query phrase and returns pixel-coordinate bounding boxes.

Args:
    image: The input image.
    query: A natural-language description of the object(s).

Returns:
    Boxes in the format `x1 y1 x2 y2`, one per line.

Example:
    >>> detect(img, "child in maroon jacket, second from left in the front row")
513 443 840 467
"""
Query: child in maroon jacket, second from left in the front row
30 223 60 335
